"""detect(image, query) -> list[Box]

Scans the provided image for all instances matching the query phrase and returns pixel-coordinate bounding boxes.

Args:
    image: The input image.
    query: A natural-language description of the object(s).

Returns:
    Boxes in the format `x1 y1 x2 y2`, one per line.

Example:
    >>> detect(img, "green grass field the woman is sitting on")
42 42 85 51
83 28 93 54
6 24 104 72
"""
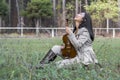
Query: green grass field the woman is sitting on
0 38 120 80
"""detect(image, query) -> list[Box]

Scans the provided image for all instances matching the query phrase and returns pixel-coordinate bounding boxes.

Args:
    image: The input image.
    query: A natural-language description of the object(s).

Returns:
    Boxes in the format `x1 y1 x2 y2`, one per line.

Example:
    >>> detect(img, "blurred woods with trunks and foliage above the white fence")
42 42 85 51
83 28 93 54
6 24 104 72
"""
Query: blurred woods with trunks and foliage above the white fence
0 0 120 28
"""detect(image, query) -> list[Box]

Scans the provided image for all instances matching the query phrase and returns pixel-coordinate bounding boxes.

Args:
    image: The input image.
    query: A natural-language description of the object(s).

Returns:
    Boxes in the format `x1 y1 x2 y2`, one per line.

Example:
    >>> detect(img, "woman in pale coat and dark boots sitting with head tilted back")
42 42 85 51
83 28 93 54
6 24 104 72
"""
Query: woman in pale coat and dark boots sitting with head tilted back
36 12 101 68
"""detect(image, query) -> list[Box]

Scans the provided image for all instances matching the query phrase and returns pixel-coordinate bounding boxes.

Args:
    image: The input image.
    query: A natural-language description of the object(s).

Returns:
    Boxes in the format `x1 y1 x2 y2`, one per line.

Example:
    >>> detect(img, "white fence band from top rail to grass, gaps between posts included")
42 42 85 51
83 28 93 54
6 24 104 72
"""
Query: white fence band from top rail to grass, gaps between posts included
0 27 120 38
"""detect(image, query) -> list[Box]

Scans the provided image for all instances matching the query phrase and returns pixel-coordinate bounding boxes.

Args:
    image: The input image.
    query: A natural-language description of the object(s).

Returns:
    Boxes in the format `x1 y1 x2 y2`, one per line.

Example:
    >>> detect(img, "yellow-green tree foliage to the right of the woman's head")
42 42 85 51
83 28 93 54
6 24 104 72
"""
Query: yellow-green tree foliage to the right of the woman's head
85 0 119 27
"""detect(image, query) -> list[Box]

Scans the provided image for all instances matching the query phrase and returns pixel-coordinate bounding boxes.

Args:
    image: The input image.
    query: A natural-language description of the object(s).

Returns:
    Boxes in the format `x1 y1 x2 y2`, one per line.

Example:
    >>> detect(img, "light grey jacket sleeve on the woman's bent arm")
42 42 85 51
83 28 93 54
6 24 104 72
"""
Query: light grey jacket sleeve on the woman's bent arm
68 28 89 49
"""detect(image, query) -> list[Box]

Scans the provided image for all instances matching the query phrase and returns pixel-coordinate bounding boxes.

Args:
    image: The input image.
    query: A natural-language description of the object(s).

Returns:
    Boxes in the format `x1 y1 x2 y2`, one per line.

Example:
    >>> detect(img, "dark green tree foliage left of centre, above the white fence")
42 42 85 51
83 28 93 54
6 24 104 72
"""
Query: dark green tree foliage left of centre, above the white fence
22 0 52 18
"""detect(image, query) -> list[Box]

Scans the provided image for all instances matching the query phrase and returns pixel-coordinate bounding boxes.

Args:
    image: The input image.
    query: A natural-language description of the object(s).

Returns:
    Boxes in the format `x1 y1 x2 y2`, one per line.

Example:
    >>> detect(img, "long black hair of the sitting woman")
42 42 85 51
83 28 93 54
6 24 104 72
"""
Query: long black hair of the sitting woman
73 12 94 41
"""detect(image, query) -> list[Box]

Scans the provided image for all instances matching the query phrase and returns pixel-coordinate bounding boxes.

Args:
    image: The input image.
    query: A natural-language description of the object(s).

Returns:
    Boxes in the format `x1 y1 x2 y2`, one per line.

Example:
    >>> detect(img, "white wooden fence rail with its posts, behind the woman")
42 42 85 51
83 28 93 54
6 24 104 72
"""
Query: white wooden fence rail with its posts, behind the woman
0 27 120 38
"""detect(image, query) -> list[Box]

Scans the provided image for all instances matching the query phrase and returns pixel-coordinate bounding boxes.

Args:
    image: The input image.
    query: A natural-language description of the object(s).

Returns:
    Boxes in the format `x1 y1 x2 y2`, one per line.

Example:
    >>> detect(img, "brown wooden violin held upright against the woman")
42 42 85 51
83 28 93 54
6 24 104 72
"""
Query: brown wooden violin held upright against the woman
61 19 77 59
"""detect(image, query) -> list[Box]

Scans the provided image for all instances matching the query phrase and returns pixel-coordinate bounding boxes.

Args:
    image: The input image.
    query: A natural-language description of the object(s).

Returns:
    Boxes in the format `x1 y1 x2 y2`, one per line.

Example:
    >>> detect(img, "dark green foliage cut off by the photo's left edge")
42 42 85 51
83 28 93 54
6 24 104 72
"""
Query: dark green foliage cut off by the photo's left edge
0 0 8 16
